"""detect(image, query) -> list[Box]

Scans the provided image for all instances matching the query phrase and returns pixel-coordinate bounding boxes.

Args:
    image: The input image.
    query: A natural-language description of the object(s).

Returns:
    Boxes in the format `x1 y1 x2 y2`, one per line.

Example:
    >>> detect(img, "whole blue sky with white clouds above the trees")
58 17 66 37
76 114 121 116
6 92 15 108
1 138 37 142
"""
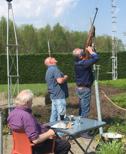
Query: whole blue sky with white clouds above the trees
0 0 126 44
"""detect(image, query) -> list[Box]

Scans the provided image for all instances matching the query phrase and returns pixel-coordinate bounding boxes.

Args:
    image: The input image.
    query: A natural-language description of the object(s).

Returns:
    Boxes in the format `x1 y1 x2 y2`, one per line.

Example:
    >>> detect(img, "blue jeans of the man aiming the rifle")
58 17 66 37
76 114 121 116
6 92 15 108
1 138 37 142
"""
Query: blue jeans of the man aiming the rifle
76 87 91 118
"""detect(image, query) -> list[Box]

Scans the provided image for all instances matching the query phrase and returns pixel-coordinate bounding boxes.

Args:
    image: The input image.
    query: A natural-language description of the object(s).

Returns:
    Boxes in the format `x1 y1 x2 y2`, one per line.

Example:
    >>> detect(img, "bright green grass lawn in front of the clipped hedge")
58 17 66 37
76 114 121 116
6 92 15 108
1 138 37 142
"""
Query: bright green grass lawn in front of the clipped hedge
0 79 126 108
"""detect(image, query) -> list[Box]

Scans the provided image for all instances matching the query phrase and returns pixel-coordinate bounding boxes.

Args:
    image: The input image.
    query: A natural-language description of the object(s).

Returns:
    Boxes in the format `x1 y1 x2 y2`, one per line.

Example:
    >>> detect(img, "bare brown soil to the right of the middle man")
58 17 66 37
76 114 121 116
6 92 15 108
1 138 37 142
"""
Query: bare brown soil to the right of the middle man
68 86 126 119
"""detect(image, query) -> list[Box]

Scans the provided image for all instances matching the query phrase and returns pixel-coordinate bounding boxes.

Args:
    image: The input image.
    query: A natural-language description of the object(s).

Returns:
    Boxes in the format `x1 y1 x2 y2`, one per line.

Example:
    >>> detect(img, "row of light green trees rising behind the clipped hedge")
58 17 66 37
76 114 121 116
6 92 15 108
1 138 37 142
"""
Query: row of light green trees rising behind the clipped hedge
0 17 125 54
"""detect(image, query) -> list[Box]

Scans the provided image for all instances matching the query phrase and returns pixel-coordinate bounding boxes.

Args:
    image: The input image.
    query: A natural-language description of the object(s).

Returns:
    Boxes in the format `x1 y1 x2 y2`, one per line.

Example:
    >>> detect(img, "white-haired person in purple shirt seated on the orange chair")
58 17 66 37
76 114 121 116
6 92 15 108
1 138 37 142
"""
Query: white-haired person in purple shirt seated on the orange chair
7 89 70 154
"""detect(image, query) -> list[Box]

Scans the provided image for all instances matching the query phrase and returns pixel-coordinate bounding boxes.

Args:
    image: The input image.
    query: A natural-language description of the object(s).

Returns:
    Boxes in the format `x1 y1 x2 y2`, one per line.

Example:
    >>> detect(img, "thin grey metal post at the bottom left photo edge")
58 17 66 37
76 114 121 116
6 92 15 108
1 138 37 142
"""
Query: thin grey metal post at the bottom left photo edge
0 111 3 154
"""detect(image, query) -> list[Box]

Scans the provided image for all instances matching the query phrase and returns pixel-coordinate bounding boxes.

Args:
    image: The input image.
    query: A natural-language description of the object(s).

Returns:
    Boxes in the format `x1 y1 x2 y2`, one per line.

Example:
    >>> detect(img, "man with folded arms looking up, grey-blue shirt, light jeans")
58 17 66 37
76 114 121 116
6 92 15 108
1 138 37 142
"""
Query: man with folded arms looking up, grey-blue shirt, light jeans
44 57 68 122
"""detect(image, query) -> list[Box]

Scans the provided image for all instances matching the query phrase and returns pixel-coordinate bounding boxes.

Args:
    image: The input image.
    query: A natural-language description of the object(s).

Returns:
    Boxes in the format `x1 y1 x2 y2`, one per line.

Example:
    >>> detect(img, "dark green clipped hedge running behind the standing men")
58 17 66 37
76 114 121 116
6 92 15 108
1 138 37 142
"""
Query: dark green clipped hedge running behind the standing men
0 52 126 84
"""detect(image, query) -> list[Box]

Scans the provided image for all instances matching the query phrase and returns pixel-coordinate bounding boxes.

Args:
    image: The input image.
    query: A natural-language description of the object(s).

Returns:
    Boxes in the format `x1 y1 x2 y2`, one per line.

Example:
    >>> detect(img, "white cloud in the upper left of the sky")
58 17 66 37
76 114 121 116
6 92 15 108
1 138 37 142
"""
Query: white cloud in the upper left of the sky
0 0 78 19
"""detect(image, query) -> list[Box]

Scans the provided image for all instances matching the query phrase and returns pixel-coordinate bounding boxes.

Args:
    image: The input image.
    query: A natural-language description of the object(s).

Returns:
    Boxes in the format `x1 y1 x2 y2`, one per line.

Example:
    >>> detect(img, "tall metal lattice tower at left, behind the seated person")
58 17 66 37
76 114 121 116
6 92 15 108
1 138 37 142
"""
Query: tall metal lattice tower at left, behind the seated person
6 0 19 112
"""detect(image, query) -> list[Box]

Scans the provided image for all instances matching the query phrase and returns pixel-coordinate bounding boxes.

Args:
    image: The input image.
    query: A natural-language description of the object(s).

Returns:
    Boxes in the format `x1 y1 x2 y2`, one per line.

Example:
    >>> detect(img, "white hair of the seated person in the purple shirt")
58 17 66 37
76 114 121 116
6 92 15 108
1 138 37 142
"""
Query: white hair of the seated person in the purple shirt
15 89 34 106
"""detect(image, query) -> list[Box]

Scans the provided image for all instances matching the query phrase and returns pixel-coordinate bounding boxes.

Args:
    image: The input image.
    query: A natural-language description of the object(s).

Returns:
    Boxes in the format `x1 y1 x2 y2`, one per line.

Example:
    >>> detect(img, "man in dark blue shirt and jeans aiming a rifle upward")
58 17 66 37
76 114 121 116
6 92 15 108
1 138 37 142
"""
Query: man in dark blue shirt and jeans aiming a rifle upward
73 47 99 117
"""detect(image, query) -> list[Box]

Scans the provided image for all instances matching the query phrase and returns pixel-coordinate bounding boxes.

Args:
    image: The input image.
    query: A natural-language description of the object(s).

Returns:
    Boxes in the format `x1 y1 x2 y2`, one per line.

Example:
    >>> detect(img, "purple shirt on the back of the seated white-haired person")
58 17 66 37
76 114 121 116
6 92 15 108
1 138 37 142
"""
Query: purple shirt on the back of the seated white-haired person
7 107 41 140
